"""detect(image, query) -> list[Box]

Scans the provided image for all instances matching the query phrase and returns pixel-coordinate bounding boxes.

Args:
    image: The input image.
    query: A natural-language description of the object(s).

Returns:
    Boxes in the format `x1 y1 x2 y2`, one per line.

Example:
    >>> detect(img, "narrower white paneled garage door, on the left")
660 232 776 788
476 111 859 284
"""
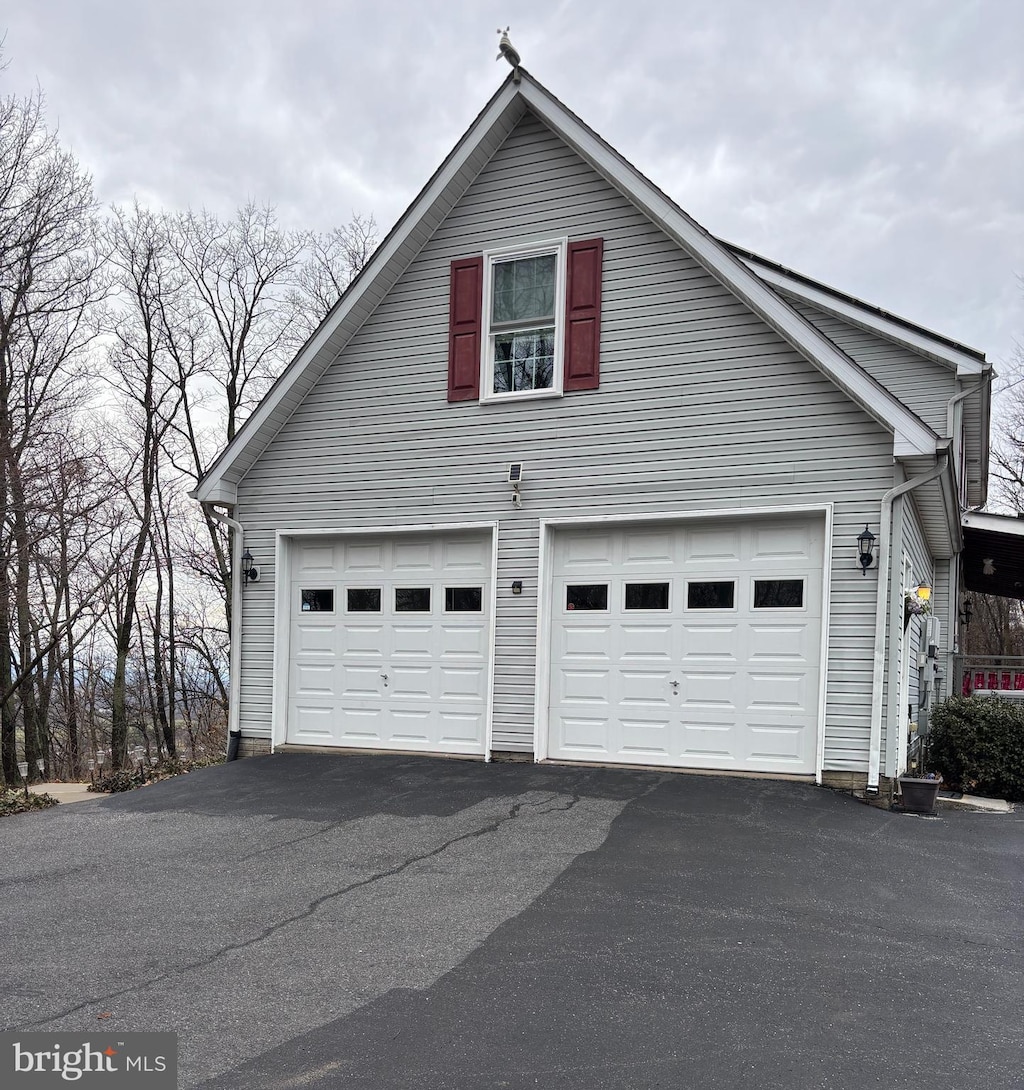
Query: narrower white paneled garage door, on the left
288 534 491 754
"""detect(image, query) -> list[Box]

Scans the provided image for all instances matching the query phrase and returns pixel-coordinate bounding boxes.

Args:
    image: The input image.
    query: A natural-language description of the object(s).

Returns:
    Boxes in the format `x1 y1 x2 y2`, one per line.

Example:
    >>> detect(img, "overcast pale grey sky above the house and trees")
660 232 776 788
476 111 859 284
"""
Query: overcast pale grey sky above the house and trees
0 0 1024 372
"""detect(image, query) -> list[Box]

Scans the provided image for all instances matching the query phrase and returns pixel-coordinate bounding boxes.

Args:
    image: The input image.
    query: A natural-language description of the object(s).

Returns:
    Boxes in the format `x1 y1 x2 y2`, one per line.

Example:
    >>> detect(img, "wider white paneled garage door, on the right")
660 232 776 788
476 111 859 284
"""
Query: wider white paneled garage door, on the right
549 519 824 774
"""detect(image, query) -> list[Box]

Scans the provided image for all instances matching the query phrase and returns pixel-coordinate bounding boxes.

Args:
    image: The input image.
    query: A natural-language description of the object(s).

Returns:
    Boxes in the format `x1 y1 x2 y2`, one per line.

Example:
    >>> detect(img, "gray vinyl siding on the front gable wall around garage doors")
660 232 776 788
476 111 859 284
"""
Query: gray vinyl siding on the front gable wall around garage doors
238 117 893 771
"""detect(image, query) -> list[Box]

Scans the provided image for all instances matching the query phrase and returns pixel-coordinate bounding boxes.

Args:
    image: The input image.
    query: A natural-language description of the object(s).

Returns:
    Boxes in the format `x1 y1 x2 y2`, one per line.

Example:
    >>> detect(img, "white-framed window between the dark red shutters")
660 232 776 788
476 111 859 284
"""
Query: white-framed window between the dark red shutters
480 239 567 401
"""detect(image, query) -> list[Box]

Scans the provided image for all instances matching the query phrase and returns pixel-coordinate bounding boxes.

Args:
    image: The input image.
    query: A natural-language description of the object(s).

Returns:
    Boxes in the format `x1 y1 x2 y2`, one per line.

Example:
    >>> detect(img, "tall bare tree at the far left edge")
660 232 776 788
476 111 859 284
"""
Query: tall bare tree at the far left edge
0 85 103 780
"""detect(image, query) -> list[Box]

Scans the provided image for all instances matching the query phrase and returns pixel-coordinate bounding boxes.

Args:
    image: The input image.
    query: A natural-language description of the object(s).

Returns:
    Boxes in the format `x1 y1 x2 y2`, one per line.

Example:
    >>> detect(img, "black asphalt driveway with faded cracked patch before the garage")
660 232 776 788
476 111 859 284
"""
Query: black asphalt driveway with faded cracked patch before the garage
0 754 1024 1090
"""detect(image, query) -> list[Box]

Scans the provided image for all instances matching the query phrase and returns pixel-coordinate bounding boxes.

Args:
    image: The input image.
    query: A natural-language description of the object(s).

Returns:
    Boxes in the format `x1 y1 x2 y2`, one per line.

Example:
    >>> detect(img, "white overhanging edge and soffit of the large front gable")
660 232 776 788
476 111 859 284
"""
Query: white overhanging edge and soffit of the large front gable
192 68 939 505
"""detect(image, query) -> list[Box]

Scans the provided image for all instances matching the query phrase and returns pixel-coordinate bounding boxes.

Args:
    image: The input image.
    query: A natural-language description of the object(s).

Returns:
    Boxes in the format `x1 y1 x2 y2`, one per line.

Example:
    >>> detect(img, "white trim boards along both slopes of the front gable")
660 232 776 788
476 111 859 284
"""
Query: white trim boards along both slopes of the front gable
192 69 938 501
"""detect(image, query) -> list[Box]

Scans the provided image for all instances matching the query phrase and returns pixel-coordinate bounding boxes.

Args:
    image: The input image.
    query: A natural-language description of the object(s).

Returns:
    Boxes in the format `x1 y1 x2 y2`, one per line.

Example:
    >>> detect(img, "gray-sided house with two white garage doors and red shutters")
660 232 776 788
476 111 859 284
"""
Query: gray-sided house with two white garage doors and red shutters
194 70 990 792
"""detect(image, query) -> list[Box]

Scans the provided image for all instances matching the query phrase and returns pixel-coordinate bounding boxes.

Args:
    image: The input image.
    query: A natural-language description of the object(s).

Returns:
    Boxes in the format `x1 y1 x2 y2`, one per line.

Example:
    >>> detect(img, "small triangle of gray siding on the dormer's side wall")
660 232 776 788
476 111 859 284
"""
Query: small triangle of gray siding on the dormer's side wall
788 298 956 436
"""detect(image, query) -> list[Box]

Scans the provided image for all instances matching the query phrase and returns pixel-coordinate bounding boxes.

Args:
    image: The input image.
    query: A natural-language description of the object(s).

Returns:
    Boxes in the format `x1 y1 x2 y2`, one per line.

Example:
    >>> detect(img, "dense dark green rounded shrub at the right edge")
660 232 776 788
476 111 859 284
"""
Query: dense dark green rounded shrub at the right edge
928 697 1024 801
